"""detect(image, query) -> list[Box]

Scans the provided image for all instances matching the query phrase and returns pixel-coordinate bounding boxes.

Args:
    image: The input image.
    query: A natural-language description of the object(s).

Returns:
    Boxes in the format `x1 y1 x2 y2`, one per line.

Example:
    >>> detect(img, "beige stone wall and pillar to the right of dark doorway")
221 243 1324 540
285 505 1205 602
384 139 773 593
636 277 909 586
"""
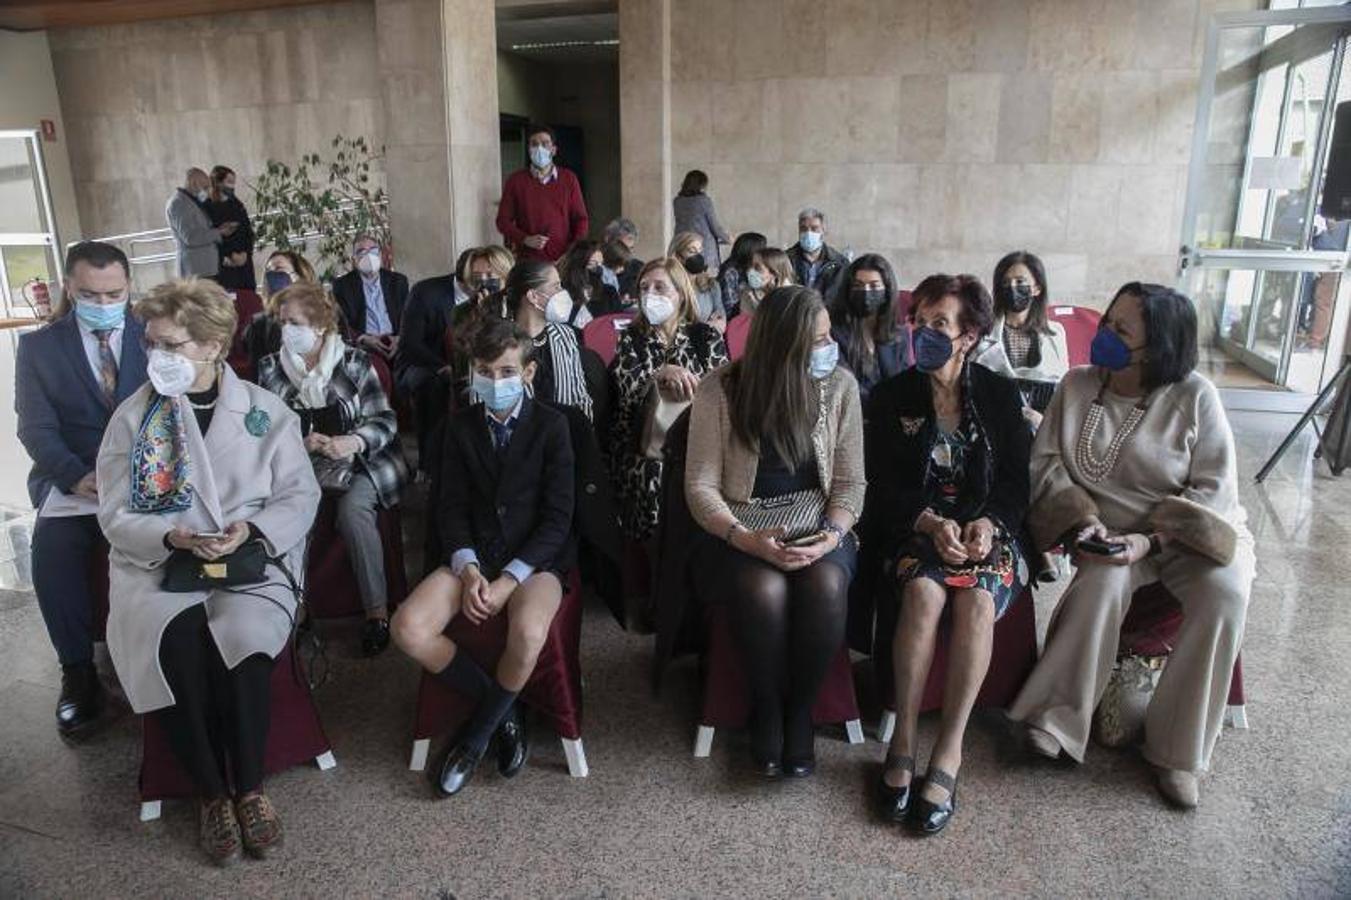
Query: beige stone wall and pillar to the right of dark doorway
620 0 1255 301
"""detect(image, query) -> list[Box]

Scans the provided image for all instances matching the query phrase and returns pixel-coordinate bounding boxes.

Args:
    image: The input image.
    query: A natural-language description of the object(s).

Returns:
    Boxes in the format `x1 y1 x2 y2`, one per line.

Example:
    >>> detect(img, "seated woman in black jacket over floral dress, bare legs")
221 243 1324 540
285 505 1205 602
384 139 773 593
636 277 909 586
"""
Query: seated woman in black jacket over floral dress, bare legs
866 276 1032 834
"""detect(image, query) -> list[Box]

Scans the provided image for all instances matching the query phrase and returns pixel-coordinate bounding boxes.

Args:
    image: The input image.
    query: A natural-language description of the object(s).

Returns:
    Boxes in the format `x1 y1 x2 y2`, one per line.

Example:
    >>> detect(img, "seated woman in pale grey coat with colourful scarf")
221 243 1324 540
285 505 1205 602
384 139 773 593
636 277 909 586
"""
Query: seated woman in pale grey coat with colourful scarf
97 278 319 864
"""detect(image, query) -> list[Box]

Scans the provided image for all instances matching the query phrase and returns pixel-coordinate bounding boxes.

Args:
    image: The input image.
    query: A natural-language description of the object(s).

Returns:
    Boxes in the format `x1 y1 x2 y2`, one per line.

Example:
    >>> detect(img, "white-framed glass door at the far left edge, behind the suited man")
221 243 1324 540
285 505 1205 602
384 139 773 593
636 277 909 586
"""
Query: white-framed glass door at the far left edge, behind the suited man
0 130 62 319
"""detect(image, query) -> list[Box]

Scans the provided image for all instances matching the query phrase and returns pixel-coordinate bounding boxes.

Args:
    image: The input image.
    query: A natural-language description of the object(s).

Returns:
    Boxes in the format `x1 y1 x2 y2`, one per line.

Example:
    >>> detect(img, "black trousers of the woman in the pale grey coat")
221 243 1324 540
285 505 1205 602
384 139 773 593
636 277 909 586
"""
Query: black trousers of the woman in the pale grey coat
155 604 273 799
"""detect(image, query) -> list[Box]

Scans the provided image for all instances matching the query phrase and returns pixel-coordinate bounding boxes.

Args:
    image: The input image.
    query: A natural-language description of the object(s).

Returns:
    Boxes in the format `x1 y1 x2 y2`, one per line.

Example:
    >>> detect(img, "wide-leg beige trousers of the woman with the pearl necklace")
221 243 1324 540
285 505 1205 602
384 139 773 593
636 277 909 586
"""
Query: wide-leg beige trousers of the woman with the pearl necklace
1009 541 1256 772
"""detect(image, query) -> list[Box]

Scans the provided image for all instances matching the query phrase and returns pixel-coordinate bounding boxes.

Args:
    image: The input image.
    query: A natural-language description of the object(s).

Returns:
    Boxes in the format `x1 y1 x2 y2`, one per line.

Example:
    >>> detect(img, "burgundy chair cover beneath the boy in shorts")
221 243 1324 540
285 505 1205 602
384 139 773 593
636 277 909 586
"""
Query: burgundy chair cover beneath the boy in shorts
413 570 582 741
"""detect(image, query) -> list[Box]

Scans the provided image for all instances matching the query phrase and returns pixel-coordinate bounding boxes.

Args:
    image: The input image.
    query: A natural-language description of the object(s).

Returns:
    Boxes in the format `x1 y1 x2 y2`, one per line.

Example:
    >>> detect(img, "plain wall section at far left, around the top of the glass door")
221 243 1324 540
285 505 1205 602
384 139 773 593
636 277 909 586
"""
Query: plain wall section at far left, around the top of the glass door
0 31 81 248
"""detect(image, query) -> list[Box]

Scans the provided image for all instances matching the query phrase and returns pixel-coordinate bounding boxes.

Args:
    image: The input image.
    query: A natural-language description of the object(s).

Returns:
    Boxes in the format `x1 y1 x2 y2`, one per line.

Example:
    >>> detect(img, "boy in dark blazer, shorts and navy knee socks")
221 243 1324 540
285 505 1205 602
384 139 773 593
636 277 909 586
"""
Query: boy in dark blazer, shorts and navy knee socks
393 319 576 797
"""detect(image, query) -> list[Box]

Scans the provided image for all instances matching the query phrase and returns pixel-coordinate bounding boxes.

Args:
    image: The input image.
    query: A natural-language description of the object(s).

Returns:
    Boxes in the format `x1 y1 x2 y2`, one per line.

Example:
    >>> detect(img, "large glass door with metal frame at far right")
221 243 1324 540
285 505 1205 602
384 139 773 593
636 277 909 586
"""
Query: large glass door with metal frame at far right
1178 4 1351 405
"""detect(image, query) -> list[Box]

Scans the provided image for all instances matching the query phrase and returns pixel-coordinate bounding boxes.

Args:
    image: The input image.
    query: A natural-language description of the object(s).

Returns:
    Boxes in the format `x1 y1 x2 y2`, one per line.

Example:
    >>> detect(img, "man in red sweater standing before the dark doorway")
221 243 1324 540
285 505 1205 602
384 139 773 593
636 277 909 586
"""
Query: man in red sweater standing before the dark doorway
497 126 590 262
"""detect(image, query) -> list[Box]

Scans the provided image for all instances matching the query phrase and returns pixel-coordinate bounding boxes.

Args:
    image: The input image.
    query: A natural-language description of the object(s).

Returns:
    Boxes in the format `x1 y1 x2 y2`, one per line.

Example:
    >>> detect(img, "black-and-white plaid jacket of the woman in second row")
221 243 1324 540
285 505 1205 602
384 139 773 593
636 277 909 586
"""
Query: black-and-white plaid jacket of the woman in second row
258 347 408 507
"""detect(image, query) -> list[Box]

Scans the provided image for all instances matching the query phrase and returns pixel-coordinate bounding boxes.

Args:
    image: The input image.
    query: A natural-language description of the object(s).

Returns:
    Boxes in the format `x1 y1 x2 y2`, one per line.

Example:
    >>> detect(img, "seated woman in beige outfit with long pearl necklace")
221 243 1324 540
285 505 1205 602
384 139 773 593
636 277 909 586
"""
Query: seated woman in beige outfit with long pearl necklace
1009 282 1255 807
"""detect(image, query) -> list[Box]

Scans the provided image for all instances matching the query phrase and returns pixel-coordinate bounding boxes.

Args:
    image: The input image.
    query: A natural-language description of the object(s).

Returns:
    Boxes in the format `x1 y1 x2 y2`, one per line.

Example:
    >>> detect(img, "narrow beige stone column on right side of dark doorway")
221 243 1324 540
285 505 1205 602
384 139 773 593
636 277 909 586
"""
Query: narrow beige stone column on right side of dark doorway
618 0 671 259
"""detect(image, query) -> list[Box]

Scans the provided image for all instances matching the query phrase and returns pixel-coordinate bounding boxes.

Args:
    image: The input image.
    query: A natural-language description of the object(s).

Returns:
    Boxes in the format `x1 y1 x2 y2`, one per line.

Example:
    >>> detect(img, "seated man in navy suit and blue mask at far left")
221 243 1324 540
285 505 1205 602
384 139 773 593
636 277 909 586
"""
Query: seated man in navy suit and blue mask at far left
15 241 146 734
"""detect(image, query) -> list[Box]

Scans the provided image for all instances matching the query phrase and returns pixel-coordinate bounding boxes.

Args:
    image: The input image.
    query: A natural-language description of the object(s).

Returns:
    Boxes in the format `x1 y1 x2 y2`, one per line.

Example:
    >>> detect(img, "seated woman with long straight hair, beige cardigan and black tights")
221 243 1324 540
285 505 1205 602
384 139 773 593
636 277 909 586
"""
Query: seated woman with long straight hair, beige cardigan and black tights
685 288 865 777
